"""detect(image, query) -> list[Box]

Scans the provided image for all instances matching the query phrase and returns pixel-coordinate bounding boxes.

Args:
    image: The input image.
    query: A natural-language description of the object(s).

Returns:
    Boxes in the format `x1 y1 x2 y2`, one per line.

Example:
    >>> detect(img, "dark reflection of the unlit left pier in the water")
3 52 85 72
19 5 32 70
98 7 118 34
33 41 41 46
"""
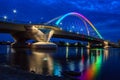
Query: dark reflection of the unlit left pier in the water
10 49 29 71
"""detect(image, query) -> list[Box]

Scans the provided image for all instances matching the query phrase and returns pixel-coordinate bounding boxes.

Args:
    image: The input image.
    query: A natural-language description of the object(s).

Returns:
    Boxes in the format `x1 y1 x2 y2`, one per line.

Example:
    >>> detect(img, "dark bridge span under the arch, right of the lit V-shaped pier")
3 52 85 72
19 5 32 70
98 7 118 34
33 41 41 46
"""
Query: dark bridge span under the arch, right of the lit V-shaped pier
53 31 104 43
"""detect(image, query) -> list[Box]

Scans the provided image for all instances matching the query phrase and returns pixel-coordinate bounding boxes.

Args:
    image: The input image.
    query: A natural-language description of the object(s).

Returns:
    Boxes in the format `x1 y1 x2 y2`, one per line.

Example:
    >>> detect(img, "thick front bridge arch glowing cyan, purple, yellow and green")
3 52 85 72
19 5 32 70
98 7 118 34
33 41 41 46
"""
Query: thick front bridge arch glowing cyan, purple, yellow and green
55 12 103 39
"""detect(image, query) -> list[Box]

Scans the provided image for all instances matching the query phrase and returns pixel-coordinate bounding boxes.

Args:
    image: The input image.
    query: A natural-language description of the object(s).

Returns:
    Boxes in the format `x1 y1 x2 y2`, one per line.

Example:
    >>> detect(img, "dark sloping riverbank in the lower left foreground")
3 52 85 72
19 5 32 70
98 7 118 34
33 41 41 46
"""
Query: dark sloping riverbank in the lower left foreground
0 65 69 80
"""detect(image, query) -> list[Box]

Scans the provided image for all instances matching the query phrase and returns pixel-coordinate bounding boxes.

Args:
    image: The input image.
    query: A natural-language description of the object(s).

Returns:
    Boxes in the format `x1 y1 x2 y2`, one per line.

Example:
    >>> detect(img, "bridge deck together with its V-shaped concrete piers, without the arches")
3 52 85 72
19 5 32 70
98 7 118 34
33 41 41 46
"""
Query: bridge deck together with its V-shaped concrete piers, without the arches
0 22 113 45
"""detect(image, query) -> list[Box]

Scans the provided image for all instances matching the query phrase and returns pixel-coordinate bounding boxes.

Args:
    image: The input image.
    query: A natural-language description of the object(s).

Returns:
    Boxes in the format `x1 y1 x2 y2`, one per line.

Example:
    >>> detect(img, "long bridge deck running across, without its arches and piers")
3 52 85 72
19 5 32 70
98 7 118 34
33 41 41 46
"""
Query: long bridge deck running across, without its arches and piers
0 21 116 45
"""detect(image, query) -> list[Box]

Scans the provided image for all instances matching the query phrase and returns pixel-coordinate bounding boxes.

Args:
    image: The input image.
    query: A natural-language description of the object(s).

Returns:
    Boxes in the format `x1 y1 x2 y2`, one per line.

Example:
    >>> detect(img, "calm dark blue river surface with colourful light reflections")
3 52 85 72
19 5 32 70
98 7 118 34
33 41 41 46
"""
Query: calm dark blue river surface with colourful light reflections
0 45 120 80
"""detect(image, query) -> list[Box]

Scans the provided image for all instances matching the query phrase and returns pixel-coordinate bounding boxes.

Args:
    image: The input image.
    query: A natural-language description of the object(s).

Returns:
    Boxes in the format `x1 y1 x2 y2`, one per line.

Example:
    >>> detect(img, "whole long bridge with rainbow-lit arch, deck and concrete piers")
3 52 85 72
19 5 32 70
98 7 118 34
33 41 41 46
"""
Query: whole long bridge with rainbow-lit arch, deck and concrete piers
0 12 115 47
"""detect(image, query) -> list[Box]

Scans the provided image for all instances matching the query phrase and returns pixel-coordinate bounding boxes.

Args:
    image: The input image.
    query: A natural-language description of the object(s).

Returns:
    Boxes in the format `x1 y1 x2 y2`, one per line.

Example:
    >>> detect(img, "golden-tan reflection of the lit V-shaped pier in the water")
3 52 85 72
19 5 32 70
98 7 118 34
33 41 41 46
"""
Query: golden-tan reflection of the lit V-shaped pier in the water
29 50 53 75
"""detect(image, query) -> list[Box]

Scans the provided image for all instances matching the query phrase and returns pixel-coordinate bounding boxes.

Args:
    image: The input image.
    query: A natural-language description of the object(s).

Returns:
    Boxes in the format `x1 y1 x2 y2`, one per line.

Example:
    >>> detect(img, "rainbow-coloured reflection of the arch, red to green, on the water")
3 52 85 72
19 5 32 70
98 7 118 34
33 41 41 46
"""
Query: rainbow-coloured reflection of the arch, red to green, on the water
80 49 103 80
